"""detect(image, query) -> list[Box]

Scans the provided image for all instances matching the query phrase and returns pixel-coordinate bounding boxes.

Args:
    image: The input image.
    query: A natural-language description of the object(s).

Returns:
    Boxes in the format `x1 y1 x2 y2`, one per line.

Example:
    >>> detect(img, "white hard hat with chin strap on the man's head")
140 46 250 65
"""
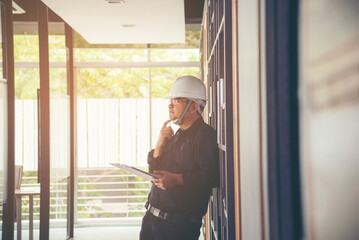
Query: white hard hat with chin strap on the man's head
169 76 206 101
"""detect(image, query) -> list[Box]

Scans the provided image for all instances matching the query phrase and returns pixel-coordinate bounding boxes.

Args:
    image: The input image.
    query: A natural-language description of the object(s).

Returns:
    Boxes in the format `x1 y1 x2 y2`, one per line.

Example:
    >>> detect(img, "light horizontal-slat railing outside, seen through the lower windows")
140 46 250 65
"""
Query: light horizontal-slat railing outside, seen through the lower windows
21 168 151 222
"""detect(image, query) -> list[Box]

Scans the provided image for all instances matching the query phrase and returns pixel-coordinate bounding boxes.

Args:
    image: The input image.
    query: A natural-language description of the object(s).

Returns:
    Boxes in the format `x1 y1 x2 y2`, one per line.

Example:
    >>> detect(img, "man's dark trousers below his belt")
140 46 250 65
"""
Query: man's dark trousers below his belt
140 211 202 240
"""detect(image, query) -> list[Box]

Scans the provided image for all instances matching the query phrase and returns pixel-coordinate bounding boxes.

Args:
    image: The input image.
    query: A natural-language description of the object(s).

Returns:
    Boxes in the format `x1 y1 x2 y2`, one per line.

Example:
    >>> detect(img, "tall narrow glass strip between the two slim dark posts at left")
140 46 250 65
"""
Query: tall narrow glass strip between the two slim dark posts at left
49 32 70 239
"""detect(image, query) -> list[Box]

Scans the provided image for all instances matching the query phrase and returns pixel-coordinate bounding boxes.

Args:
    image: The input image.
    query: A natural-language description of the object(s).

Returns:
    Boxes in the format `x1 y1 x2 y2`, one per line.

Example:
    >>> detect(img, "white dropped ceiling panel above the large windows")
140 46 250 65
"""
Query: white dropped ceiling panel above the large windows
42 0 185 44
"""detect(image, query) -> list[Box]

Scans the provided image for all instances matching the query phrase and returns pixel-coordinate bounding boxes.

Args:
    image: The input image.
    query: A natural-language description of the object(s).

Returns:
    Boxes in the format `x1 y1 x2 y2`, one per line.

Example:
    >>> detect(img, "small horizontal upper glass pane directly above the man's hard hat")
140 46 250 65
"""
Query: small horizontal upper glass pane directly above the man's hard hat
151 49 199 62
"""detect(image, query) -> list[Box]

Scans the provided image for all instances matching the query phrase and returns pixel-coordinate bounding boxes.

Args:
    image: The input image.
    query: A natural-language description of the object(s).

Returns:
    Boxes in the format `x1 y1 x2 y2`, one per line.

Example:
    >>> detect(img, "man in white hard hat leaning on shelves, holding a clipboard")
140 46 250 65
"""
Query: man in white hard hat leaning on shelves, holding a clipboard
140 76 219 240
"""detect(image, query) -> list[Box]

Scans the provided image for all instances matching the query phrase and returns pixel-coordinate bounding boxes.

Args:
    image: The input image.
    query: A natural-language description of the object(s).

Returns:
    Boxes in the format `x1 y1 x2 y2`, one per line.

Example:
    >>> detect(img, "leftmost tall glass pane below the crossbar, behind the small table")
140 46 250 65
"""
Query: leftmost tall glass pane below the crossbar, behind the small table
15 64 40 232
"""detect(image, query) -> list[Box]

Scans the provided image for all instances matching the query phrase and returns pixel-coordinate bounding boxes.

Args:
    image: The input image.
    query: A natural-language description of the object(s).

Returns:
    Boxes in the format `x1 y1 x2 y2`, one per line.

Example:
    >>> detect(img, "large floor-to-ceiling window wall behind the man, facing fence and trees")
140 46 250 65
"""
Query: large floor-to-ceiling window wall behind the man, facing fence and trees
14 32 200 224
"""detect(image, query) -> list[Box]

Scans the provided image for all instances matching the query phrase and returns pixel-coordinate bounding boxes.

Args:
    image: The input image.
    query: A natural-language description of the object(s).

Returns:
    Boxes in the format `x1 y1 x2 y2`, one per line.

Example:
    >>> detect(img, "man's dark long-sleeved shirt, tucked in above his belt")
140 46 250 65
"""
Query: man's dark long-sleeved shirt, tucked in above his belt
148 118 219 217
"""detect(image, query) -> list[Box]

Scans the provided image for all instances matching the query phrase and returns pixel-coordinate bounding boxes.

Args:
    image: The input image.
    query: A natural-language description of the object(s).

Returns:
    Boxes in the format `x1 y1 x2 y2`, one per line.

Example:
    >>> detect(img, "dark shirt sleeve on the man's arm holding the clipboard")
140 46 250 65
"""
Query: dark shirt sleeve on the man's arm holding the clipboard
182 127 219 189
